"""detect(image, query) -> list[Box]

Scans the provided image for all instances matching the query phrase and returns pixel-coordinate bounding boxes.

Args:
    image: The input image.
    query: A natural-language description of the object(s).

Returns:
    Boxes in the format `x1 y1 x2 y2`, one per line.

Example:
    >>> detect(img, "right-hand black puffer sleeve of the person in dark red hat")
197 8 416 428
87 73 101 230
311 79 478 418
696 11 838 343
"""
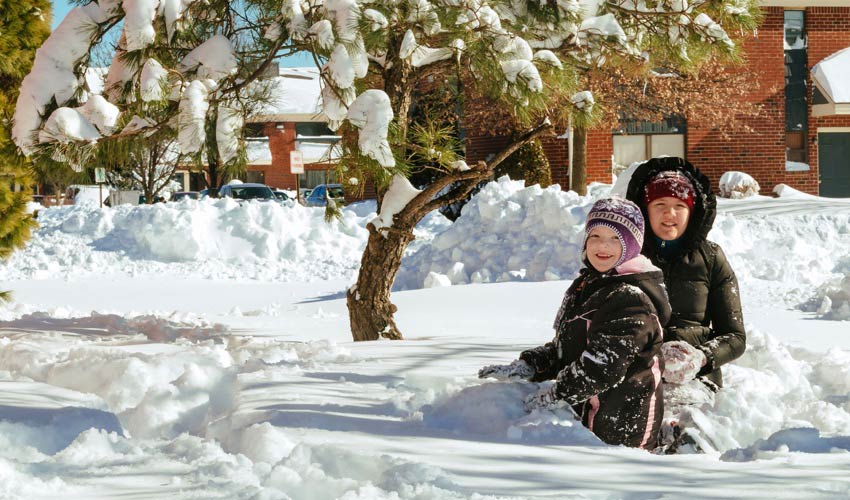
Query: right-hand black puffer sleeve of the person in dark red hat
699 244 747 375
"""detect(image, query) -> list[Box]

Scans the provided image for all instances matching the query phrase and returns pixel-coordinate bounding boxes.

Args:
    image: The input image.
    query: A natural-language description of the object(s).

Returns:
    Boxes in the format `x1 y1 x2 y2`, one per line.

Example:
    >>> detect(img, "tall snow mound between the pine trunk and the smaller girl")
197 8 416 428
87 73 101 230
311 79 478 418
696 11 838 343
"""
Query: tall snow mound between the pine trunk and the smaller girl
396 177 594 290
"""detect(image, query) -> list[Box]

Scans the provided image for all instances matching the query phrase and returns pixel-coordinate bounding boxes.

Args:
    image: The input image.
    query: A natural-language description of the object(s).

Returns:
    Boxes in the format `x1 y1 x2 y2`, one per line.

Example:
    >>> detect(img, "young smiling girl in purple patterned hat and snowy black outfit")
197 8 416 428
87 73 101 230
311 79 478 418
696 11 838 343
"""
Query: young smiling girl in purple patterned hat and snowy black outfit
478 198 670 449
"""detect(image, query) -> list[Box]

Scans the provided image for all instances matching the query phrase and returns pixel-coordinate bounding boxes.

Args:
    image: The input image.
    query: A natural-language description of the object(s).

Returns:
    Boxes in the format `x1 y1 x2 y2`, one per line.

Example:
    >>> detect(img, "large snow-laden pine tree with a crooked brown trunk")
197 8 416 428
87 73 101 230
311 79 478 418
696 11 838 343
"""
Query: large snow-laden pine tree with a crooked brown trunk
14 0 754 340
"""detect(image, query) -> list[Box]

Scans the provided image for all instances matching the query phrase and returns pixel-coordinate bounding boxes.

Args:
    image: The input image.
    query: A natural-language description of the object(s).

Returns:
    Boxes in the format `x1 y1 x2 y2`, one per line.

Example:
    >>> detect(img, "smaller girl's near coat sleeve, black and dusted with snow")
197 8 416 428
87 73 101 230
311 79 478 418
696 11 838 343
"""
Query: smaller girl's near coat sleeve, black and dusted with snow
555 286 655 405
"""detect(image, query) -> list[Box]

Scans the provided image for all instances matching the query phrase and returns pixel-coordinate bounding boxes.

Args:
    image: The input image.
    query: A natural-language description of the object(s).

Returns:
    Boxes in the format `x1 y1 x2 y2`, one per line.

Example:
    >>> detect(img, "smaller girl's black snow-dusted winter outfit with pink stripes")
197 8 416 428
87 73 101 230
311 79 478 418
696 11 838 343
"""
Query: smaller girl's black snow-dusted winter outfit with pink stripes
520 257 670 449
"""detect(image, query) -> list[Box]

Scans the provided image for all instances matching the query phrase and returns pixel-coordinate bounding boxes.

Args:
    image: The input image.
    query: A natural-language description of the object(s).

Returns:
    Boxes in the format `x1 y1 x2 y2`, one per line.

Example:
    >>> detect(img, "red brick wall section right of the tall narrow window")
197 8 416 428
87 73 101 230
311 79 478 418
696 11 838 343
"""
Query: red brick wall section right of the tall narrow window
806 7 850 192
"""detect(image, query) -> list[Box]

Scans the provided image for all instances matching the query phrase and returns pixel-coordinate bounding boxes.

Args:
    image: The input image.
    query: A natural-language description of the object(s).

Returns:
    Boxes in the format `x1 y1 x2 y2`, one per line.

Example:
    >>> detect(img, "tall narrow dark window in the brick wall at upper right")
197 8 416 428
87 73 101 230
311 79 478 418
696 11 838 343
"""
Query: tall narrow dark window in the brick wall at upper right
784 10 809 163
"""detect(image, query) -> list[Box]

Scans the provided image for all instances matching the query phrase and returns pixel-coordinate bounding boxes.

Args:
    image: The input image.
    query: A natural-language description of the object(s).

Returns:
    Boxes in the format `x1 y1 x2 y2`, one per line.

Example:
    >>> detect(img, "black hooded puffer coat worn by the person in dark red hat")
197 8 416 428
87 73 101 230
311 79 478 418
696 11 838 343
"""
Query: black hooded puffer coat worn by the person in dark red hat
626 157 746 387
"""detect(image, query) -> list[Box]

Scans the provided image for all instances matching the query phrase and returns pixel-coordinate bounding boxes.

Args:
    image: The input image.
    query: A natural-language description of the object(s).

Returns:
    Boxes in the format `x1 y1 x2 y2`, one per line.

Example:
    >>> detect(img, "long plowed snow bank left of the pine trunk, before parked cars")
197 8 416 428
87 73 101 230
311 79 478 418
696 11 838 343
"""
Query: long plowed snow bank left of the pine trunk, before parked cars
0 198 450 281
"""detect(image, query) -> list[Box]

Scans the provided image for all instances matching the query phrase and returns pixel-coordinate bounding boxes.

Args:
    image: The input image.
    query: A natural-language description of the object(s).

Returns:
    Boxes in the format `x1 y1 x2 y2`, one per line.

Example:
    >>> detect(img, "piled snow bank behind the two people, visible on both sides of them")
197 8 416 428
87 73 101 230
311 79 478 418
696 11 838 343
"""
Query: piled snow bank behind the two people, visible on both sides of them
396 177 850 290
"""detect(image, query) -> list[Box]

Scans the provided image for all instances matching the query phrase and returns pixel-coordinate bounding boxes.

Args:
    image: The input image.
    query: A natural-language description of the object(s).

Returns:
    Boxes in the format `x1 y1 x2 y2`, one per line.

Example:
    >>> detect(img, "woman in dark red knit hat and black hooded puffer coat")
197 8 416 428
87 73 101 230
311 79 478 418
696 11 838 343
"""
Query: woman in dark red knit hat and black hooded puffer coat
626 157 746 389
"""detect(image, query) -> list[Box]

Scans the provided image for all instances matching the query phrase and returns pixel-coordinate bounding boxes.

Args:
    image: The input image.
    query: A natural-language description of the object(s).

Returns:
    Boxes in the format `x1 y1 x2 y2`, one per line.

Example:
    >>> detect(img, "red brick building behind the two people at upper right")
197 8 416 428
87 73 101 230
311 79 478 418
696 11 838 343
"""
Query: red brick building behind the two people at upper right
467 0 850 197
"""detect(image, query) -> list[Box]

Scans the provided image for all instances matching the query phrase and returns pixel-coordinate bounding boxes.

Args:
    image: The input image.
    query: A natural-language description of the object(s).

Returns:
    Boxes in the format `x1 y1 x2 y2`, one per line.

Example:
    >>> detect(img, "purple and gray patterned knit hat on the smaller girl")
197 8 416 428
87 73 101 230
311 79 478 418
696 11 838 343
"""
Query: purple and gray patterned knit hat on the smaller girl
584 198 644 267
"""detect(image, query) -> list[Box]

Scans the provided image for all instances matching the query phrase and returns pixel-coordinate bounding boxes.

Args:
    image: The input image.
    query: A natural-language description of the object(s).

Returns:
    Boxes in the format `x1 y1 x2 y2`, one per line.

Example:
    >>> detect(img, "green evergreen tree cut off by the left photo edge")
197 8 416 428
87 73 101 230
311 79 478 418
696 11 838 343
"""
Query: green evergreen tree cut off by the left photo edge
0 0 50 300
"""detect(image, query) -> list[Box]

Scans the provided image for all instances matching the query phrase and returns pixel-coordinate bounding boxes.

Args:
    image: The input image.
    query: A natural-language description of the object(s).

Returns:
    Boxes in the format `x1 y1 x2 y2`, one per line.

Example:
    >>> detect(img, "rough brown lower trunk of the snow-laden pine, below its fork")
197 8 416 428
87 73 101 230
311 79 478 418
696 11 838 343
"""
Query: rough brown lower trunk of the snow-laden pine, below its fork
346 224 414 342
